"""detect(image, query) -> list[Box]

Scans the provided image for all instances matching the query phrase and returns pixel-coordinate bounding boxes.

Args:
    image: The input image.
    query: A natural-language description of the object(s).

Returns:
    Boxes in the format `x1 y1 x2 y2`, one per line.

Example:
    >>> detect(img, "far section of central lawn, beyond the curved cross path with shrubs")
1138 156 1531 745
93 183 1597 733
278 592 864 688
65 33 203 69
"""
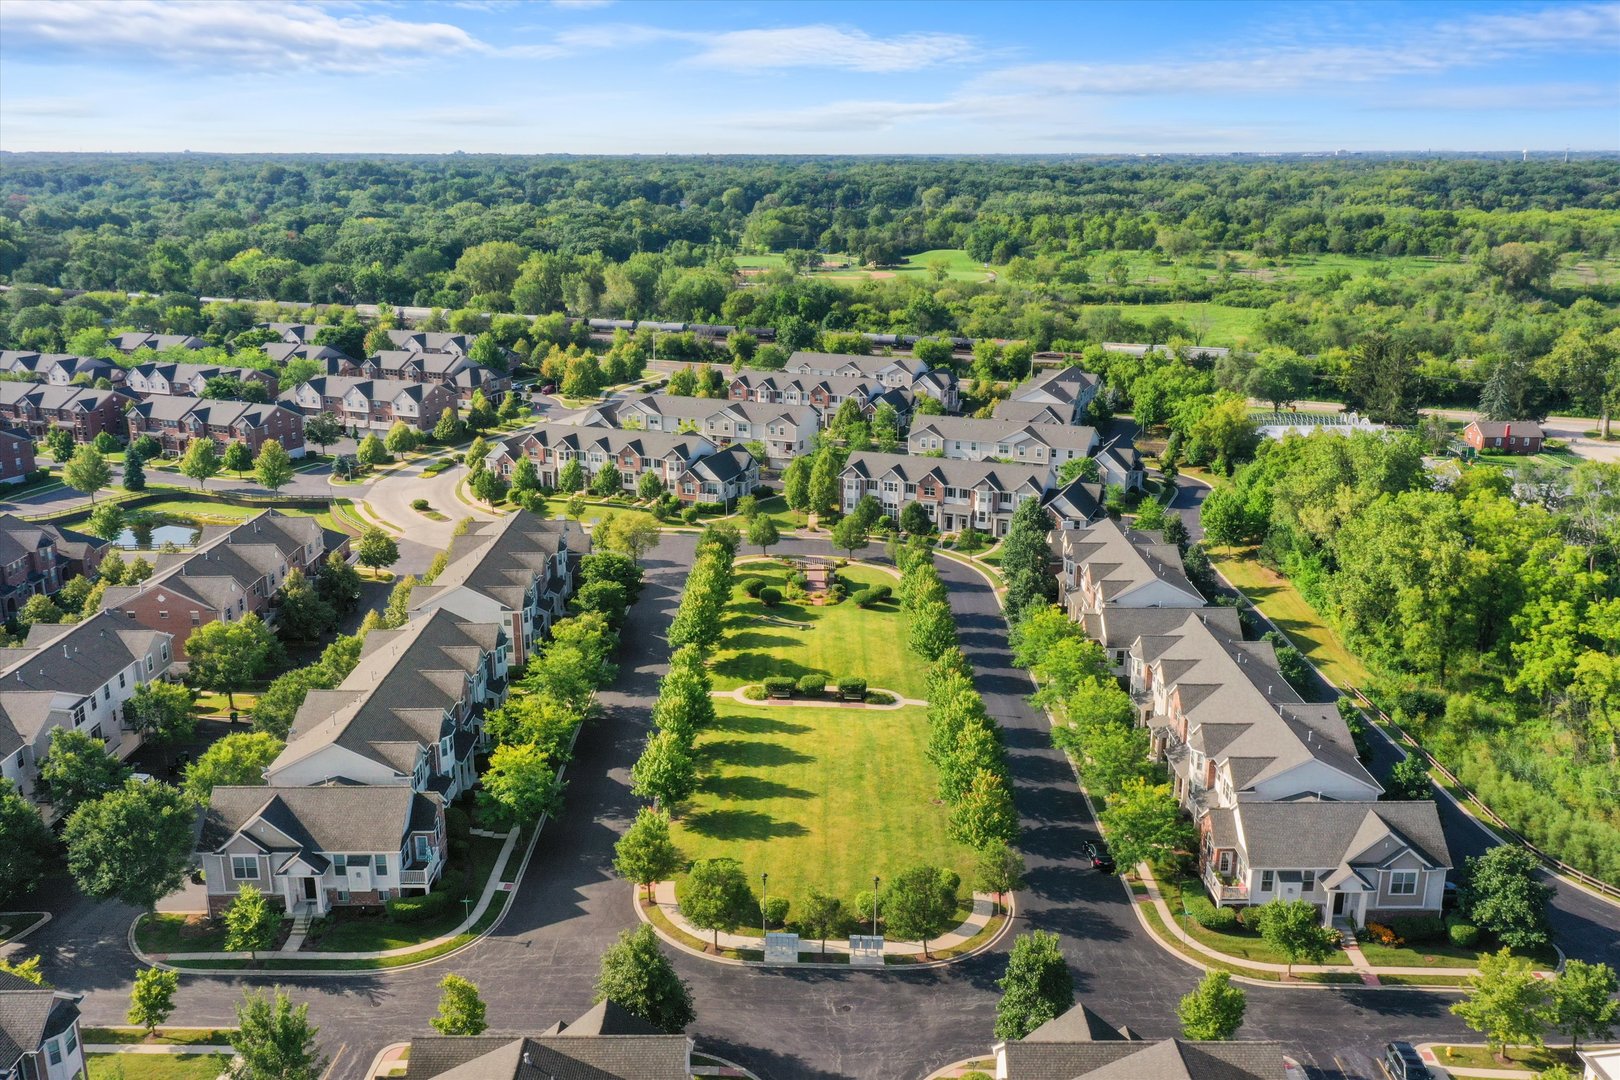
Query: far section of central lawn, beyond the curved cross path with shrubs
710 560 927 698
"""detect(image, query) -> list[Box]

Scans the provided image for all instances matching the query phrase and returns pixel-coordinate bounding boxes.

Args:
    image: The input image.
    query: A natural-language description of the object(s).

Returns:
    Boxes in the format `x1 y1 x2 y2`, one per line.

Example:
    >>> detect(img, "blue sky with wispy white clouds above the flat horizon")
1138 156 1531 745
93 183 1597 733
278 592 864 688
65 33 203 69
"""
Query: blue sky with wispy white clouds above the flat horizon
0 0 1620 154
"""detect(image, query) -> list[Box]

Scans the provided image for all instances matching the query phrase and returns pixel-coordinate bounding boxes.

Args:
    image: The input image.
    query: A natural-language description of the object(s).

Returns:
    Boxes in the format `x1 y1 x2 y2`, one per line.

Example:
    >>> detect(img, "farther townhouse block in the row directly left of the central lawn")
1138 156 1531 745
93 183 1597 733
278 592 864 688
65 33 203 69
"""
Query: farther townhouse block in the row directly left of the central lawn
410 513 591 667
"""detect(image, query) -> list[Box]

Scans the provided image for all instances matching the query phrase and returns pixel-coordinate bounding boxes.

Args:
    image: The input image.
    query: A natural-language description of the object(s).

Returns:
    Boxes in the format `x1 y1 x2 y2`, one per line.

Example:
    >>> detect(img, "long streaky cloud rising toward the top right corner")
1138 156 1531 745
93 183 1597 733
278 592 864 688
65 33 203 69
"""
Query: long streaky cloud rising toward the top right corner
983 5 1620 96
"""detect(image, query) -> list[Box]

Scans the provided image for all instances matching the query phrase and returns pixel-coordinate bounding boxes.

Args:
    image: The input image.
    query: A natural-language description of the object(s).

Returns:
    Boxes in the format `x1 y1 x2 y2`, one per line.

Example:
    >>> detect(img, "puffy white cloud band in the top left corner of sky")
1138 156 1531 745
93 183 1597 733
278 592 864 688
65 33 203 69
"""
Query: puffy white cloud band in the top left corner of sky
0 0 556 71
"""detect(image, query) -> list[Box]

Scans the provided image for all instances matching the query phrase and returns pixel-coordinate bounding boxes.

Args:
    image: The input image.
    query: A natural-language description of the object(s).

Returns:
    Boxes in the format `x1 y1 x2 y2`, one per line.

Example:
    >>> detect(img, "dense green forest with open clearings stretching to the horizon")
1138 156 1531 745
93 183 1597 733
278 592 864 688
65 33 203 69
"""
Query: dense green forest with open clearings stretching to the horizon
0 154 1620 416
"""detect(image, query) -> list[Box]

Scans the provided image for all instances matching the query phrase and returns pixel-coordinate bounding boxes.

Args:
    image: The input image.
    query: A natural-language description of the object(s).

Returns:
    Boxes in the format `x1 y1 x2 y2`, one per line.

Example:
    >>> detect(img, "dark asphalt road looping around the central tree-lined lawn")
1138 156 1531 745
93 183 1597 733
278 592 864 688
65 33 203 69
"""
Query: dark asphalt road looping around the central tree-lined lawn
10 534 1568 1080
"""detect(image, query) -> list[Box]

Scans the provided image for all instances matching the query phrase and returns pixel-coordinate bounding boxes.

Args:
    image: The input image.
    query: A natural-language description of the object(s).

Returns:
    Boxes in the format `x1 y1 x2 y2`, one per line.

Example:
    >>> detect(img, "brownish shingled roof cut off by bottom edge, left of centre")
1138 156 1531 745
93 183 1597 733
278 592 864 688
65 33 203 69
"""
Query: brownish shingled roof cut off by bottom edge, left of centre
405 1001 695 1080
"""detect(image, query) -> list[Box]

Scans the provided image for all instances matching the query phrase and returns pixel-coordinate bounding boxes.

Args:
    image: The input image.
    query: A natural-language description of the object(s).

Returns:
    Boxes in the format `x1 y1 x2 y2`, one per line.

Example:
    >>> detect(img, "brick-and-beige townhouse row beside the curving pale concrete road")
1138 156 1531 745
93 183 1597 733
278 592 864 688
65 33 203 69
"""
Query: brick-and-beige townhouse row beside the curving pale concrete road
484 424 716 491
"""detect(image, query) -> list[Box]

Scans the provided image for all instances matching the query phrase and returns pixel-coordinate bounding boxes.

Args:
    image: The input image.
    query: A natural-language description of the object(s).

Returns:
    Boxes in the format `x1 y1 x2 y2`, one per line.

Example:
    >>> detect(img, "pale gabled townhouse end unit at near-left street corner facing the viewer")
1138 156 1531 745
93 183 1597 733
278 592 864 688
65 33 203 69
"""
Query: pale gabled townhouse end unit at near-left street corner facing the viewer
198 784 449 916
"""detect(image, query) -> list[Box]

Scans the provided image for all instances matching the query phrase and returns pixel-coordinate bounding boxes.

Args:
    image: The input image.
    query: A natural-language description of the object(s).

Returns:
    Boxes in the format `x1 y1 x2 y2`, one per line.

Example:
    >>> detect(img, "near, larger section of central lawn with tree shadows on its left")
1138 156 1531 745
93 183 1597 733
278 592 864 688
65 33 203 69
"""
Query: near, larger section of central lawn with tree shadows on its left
674 701 974 918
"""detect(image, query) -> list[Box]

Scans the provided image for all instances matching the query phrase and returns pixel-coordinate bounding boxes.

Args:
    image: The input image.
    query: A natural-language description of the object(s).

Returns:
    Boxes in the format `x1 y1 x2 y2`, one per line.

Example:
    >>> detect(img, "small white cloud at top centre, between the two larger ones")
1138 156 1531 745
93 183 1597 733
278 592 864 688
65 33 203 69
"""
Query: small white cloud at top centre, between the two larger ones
557 23 975 71
